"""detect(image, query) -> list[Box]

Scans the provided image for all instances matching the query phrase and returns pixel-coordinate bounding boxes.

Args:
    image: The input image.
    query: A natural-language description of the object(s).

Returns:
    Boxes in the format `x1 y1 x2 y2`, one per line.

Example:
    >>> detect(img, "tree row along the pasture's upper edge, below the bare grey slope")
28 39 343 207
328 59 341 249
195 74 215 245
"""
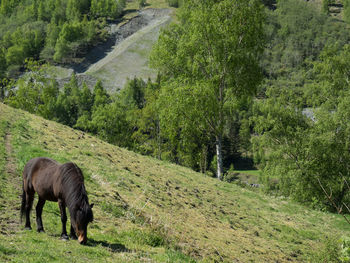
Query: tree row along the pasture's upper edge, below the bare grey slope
4 67 250 173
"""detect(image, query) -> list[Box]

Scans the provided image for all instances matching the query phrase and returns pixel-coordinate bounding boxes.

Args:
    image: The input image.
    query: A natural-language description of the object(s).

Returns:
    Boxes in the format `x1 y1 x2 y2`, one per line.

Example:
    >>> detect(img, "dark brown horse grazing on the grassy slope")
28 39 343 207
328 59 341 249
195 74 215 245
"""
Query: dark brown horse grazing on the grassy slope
21 157 93 244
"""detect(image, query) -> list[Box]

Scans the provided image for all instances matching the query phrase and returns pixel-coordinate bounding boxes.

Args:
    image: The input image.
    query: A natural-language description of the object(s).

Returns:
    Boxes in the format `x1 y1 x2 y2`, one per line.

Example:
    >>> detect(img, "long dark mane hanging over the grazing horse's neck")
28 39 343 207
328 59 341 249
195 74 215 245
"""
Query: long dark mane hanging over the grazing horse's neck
60 162 92 221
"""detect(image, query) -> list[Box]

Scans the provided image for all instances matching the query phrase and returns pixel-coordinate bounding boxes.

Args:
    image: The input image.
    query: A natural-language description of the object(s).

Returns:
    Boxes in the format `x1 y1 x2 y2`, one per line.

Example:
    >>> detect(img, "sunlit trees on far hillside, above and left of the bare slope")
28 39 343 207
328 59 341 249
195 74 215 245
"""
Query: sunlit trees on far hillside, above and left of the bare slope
0 0 125 74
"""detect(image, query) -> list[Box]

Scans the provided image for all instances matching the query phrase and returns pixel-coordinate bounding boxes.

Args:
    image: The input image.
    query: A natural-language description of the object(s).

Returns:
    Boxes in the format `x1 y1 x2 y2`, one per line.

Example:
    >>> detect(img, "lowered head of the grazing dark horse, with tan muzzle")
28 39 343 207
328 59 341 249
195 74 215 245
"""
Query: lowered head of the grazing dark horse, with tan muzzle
72 203 94 245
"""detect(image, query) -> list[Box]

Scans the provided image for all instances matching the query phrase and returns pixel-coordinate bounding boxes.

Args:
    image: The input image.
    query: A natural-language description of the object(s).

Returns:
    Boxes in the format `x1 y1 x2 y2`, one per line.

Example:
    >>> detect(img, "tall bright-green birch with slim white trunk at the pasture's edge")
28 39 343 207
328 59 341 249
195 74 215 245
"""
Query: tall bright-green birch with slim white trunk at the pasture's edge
151 0 264 179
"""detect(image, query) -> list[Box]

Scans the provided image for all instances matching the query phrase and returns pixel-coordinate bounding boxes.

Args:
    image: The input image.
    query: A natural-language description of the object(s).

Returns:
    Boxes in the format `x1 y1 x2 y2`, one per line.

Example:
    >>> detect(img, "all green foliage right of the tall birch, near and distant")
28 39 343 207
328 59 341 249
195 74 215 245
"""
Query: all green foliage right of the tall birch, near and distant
249 0 350 210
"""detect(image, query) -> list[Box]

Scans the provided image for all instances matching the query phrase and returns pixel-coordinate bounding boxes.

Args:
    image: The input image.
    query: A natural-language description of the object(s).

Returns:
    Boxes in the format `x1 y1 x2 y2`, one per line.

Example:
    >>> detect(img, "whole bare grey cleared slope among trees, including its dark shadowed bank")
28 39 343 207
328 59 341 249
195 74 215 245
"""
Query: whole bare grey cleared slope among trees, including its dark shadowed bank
48 5 175 92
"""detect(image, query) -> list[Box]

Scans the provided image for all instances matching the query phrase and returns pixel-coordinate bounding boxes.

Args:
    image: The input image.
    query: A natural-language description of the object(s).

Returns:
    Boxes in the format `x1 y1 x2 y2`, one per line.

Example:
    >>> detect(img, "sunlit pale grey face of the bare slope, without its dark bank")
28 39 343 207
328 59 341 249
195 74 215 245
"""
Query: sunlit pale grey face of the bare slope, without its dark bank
85 9 171 91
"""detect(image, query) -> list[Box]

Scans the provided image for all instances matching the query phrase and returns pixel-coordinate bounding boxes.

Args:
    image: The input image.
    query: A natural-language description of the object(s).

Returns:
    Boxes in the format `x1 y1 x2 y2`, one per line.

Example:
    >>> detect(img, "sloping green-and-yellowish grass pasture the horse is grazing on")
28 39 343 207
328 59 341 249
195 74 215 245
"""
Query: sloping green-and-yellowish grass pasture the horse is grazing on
0 104 350 262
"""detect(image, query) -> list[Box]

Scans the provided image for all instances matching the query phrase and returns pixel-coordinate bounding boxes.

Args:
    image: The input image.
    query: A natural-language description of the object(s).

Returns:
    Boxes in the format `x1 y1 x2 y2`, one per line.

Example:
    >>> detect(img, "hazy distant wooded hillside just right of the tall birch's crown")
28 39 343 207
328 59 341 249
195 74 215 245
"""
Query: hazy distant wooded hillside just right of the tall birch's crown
262 0 349 93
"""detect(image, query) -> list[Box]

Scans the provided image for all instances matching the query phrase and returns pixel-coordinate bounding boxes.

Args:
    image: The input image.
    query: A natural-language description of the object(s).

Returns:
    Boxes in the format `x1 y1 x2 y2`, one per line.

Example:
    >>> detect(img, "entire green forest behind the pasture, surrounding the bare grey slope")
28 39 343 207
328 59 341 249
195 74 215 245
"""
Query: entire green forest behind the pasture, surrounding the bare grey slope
0 0 350 212
